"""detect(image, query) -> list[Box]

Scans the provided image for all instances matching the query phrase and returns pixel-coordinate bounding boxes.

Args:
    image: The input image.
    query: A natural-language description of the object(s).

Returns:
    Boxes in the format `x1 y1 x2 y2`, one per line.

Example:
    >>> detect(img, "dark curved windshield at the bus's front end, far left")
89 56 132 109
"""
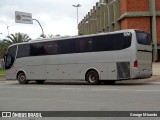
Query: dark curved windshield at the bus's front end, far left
5 46 17 69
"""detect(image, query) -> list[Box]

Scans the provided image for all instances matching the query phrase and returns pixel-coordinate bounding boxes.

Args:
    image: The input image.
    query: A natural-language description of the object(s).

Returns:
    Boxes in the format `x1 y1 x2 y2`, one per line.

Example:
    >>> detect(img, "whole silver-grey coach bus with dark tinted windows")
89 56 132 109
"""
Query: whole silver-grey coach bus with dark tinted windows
5 30 152 84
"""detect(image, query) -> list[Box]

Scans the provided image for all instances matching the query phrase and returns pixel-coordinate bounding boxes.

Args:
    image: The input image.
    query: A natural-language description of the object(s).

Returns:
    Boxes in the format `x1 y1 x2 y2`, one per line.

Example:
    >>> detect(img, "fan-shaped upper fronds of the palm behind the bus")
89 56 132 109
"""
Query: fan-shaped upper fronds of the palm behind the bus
3 33 31 45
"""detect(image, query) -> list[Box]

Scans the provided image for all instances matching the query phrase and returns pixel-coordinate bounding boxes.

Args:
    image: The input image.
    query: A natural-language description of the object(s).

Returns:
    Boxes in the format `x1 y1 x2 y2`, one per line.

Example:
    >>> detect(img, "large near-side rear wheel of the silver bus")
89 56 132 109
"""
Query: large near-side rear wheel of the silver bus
86 70 99 85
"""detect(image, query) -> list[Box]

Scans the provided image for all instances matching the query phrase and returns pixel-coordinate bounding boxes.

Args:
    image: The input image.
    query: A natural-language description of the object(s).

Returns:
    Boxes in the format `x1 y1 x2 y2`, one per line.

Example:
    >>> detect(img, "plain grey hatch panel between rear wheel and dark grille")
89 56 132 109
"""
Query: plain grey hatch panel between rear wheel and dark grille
108 63 117 80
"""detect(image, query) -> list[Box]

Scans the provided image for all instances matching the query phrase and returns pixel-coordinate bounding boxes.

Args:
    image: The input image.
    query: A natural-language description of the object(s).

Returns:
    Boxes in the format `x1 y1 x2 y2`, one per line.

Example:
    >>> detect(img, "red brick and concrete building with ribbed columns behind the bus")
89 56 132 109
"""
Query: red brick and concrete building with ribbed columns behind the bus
78 0 160 61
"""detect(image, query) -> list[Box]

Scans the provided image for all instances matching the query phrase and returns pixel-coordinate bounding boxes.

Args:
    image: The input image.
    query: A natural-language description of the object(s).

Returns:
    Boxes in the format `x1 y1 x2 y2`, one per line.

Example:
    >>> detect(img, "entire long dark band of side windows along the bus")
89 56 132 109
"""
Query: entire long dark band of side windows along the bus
14 32 132 57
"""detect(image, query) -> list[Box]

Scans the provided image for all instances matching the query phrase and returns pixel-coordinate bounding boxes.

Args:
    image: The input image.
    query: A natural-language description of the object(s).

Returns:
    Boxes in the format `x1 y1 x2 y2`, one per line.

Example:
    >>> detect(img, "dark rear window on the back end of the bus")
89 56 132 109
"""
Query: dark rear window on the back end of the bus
136 31 152 45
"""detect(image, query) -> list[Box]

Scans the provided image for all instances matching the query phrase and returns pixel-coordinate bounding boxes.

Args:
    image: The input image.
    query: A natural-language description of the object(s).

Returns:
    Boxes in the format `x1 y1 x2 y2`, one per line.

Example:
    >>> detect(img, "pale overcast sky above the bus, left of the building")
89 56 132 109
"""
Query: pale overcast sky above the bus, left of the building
0 0 99 39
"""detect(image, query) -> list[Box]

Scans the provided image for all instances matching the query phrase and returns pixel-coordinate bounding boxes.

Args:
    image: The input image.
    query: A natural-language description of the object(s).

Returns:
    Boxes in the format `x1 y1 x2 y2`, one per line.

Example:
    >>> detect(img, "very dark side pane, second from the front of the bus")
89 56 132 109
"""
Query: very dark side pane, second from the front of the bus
30 43 44 56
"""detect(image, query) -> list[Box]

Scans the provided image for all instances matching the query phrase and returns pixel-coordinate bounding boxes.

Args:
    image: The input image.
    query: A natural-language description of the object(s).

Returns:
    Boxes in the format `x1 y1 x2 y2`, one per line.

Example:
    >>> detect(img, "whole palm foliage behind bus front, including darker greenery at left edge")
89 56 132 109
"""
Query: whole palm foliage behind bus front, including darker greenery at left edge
0 33 31 58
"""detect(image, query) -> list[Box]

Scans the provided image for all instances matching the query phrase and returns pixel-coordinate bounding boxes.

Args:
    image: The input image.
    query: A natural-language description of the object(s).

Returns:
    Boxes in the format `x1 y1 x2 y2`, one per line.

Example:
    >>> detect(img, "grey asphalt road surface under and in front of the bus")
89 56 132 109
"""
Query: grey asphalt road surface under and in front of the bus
0 77 160 120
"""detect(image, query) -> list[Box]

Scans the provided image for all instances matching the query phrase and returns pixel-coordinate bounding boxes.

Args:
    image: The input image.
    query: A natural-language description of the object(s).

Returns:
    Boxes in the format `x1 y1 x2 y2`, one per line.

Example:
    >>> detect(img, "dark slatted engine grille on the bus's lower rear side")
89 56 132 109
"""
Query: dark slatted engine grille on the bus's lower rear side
117 62 130 79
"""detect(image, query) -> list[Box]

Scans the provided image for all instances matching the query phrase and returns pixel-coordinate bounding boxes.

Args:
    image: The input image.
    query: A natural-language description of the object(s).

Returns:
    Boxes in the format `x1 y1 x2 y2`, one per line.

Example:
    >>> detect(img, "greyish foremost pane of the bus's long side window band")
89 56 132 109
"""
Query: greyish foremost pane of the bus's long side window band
17 44 30 58
